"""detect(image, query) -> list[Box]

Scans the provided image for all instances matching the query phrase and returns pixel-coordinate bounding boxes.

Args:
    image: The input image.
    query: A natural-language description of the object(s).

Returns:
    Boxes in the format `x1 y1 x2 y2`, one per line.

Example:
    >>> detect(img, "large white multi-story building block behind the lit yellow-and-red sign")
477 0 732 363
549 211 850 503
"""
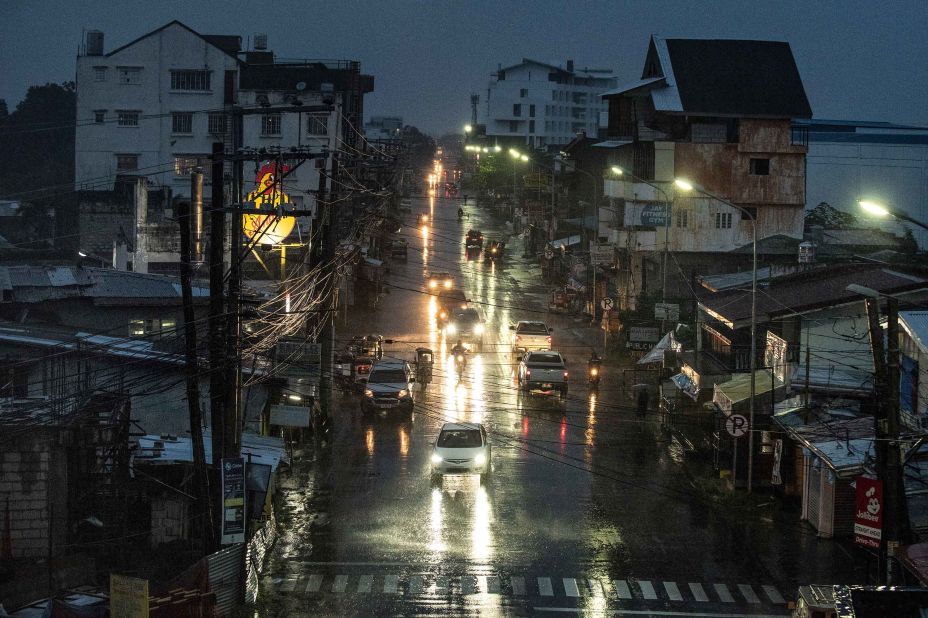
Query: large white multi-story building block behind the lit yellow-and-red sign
75 21 373 213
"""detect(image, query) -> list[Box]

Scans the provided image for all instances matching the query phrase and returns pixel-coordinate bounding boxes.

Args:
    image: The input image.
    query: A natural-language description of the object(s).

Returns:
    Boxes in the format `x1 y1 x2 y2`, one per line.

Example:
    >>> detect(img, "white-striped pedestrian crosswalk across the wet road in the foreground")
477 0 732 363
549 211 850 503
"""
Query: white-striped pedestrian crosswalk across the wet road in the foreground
265 573 787 606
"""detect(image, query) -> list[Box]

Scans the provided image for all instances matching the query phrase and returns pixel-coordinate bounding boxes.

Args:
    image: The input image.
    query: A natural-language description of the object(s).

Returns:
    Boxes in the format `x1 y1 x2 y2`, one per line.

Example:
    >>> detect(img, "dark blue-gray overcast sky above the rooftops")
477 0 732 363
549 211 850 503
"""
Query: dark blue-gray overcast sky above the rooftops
0 0 928 134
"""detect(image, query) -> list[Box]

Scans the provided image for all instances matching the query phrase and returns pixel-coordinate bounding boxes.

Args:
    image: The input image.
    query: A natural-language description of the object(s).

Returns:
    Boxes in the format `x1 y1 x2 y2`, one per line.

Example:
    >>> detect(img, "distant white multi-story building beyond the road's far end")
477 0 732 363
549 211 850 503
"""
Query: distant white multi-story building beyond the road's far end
486 58 616 148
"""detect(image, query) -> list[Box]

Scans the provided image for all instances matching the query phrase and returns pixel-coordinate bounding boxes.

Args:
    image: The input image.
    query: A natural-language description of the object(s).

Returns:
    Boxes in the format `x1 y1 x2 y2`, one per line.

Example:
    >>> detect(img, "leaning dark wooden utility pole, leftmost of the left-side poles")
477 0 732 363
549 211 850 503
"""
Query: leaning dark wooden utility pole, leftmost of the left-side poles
178 190 216 554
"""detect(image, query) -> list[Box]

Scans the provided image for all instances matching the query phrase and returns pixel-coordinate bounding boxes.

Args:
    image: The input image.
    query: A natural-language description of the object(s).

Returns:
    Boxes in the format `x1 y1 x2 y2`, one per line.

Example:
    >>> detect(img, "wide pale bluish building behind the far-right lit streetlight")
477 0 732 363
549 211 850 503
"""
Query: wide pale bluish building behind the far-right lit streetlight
793 119 928 248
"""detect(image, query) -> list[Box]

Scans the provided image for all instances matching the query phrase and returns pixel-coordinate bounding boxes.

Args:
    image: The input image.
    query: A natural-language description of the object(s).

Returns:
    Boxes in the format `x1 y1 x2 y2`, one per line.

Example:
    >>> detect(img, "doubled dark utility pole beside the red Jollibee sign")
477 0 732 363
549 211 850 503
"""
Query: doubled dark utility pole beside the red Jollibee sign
865 295 910 585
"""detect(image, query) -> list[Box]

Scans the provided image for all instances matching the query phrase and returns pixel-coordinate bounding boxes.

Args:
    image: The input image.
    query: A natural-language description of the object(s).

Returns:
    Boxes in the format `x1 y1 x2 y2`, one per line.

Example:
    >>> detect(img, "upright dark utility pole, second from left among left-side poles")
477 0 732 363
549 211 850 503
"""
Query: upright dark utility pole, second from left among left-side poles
208 142 227 500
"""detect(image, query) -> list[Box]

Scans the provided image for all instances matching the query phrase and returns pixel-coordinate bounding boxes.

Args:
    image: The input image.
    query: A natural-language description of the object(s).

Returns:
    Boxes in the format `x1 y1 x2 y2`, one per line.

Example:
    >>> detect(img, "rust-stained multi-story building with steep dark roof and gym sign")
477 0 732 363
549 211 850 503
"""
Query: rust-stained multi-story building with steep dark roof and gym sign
599 37 812 307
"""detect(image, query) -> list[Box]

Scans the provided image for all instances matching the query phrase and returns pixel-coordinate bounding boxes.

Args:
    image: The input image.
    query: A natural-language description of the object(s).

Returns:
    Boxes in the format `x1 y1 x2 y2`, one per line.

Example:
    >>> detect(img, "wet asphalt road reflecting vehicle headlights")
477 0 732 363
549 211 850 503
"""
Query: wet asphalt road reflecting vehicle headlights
258 198 864 616
